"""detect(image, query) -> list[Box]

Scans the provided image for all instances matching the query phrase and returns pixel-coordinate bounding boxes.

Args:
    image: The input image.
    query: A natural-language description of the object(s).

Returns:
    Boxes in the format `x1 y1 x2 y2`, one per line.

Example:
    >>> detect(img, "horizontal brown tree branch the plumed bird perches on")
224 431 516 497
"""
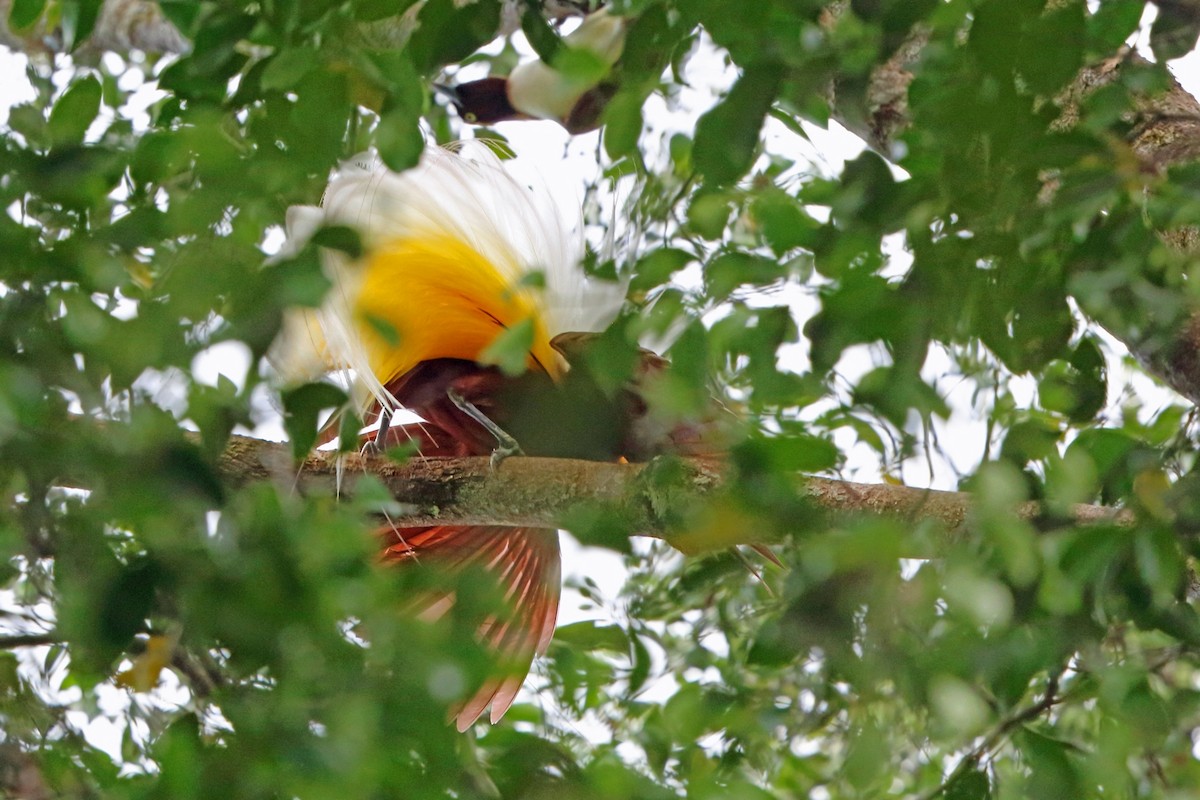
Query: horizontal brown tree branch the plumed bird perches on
220 437 1133 545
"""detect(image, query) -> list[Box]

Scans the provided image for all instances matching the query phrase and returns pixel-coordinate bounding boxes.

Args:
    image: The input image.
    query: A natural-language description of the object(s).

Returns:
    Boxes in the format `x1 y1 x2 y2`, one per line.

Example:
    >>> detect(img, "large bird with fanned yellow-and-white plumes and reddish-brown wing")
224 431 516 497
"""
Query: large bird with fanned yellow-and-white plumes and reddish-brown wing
271 145 624 729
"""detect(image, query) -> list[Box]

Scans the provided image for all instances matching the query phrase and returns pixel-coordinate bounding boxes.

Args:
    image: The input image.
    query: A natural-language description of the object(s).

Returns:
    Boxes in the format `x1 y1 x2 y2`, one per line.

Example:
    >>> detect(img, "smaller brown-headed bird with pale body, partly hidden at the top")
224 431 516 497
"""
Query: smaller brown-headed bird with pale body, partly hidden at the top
438 7 626 133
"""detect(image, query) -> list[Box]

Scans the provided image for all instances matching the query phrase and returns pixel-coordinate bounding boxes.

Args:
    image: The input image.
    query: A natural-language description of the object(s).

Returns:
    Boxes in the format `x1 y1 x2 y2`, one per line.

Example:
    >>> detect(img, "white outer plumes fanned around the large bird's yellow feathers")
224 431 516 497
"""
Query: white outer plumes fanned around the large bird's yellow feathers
271 144 625 408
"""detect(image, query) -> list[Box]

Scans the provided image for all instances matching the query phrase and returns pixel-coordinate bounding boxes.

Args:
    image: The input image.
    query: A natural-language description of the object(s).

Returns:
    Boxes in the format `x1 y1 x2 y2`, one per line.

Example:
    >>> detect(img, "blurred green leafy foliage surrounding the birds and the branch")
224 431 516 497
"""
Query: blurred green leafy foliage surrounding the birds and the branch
0 0 1200 800
